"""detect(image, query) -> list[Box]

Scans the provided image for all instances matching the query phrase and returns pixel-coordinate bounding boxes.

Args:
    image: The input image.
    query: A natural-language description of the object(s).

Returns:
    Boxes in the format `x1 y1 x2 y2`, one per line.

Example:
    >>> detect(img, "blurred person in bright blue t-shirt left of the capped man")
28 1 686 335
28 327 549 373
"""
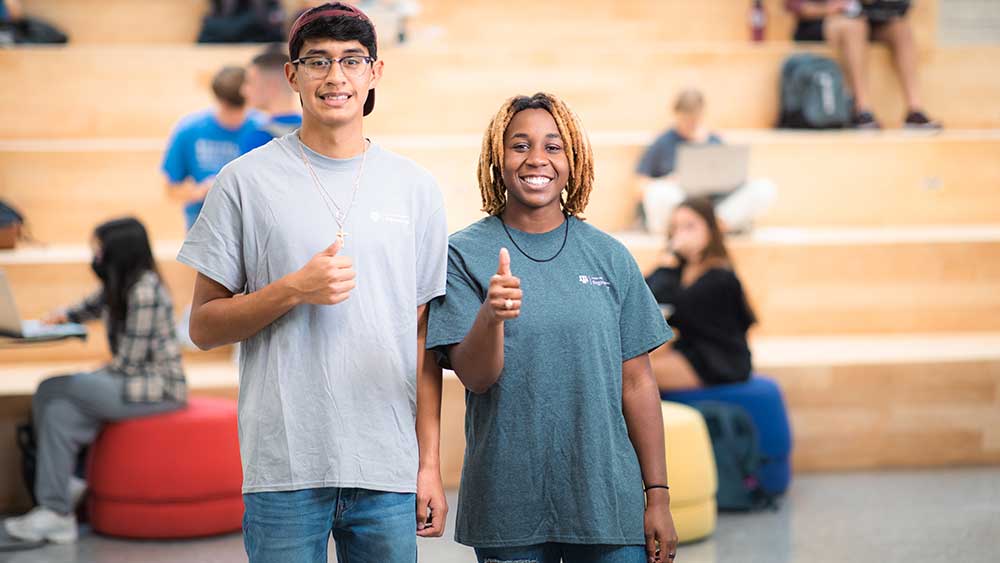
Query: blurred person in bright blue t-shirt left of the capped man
163 67 255 229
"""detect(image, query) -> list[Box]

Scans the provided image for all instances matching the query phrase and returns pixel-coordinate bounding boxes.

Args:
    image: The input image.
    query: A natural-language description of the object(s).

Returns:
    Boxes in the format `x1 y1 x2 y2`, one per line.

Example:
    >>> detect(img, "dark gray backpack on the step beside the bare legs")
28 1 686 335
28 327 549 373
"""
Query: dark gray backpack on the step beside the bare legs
778 54 850 129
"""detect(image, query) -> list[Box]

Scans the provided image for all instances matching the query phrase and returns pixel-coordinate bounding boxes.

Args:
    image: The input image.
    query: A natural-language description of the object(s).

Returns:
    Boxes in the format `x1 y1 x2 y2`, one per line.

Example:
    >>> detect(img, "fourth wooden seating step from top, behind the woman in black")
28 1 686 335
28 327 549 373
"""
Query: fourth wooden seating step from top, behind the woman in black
0 227 1000 346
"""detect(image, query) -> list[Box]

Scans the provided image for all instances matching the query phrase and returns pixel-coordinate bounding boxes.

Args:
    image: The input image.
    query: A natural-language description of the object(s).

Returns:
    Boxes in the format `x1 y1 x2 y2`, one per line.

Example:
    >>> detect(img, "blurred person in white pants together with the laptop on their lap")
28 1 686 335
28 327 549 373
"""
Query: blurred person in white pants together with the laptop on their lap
637 89 777 234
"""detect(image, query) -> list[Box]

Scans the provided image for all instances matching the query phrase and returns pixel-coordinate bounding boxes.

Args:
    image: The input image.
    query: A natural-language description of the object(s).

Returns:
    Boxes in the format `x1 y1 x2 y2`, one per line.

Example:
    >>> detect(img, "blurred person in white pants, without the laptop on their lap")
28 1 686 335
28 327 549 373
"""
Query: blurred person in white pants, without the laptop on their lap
636 89 777 234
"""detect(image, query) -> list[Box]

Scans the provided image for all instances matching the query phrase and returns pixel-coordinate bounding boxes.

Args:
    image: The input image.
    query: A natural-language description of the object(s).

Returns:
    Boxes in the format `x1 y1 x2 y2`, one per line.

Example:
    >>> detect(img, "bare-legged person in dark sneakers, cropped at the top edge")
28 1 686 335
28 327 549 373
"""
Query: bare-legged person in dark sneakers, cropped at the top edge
785 0 941 129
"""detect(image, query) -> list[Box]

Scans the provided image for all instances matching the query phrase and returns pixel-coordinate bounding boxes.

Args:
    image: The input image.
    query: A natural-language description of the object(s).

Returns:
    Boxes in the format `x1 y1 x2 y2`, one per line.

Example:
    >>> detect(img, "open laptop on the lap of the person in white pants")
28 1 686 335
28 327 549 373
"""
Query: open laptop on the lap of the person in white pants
676 145 750 196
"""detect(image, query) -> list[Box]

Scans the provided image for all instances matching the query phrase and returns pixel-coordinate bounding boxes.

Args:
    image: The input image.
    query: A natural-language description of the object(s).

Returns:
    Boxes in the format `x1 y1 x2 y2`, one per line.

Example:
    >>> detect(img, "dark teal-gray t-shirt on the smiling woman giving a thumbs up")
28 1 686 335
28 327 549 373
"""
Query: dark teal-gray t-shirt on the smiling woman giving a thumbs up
427 217 671 547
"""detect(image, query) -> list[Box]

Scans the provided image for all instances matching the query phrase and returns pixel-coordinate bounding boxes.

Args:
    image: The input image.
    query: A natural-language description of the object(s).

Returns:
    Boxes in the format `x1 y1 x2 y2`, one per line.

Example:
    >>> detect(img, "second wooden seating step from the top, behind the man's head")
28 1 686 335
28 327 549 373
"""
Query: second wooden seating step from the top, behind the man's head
0 44 1000 139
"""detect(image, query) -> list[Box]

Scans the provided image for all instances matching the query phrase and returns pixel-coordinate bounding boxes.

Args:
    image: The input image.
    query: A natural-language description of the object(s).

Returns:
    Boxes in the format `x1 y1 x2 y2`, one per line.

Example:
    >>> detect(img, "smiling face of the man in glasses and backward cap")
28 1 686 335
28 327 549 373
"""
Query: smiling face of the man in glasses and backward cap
286 39 383 127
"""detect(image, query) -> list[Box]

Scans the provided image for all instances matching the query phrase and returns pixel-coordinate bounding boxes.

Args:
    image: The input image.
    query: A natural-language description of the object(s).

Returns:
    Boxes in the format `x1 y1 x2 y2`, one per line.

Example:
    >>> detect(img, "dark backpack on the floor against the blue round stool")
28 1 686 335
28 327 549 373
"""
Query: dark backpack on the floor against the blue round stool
692 401 777 511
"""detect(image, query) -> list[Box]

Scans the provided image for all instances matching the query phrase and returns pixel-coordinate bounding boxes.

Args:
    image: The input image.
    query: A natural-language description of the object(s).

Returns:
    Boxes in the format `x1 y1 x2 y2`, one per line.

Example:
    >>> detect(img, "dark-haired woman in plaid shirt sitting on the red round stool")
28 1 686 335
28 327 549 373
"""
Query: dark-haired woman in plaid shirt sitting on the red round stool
4 218 187 543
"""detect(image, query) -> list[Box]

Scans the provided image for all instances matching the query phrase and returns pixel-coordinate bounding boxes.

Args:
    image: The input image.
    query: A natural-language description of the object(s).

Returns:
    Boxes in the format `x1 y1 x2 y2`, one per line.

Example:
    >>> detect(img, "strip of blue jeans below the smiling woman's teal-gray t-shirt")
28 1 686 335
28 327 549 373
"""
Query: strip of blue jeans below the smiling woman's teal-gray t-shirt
476 543 646 563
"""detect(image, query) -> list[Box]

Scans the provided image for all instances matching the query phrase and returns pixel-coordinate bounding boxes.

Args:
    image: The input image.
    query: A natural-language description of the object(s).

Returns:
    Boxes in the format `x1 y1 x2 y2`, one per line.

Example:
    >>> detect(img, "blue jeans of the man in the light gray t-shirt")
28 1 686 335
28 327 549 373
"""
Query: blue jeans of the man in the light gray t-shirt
243 487 417 563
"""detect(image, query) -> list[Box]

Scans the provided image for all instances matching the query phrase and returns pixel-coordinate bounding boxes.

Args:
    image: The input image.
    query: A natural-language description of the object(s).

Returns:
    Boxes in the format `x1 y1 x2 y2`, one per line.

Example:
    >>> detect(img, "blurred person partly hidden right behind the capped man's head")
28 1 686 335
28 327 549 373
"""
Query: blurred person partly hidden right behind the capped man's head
239 45 302 154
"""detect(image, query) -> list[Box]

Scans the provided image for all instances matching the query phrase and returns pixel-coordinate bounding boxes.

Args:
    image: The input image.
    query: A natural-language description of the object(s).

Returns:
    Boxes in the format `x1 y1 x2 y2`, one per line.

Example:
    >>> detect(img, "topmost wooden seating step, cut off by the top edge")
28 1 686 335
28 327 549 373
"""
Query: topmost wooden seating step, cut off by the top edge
28 0 938 45
